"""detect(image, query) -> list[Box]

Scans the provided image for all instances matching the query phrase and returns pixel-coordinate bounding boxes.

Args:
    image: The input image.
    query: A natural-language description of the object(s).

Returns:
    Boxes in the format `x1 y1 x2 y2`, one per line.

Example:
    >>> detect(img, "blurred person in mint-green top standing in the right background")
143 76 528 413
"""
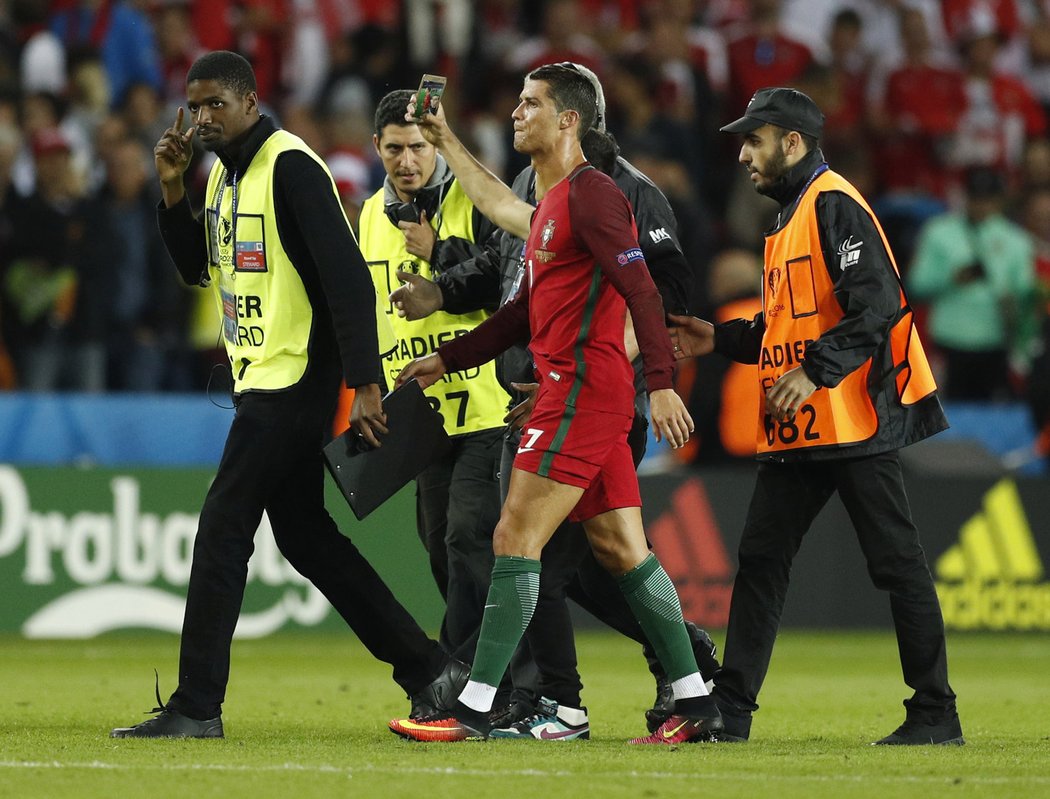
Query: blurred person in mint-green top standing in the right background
907 167 1035 400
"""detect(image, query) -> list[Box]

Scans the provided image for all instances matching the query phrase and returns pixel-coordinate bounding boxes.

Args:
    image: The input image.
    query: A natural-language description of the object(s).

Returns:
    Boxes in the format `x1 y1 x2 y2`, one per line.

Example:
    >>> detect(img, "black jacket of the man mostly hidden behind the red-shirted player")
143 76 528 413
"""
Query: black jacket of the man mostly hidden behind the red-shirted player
435 157 694 415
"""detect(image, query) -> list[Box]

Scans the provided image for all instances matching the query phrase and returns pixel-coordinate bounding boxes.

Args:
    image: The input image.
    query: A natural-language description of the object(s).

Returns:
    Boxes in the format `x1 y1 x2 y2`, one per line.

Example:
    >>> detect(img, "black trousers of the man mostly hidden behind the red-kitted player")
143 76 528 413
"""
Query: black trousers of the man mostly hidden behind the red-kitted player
500 417 649 708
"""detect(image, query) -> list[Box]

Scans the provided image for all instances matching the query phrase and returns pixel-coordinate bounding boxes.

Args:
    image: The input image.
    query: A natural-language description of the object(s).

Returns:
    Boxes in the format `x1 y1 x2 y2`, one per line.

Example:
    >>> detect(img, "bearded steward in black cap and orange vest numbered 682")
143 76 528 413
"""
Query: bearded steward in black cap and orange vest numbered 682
672 88 963 744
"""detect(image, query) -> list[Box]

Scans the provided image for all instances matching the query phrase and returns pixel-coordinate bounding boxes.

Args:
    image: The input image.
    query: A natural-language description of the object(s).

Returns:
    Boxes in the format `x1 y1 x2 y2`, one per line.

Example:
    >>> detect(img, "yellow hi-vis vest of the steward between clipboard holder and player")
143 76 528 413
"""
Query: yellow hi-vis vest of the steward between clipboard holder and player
359 181 509 436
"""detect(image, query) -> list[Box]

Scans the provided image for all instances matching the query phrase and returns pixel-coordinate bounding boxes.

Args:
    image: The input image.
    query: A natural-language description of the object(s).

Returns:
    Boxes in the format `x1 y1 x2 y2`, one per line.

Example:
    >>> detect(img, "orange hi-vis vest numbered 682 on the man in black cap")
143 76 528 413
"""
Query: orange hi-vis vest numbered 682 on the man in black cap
758 170 937 455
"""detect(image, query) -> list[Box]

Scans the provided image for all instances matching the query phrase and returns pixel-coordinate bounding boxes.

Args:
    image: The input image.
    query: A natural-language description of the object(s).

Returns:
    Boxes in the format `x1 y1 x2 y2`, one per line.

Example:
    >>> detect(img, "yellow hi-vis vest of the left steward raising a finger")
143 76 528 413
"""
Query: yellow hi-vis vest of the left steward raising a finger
205 130 394 394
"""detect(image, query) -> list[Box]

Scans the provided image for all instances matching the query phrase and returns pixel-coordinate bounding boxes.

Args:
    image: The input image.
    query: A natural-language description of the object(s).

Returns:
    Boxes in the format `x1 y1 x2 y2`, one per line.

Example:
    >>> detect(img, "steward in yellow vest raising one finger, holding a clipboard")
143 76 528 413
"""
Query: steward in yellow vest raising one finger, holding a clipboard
111 51 467 738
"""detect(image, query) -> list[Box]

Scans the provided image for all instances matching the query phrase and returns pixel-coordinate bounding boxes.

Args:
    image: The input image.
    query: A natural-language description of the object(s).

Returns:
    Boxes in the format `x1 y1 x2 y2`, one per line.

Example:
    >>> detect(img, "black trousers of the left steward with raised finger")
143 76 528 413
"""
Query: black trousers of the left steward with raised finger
169 381 447 718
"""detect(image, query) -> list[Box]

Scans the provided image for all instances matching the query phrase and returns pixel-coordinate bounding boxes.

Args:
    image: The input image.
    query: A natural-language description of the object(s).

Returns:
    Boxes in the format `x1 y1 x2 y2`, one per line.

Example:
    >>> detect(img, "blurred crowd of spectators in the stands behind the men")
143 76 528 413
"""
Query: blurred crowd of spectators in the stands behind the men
0 0 1050 457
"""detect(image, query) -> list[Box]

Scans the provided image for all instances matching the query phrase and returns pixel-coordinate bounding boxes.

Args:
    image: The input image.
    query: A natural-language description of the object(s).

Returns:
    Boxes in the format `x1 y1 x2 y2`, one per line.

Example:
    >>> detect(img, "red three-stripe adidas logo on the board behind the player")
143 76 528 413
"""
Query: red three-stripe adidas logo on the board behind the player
646 478 734 628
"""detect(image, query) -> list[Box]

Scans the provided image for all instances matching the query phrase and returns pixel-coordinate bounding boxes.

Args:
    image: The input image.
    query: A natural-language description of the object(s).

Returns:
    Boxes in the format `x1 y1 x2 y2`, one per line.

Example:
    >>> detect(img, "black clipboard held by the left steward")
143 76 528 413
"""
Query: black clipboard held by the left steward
323 380 452 520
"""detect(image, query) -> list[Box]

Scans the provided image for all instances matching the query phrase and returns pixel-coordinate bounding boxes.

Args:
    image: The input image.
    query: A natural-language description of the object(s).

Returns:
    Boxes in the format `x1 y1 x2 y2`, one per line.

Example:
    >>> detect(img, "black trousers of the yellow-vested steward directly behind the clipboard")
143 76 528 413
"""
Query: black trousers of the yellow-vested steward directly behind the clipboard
416 427 503 663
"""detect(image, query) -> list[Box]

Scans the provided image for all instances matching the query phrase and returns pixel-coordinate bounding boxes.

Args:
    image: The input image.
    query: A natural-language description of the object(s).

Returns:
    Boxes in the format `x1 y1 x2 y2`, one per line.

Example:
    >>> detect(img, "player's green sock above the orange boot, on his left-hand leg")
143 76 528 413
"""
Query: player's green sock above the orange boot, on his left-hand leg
470 555 540 686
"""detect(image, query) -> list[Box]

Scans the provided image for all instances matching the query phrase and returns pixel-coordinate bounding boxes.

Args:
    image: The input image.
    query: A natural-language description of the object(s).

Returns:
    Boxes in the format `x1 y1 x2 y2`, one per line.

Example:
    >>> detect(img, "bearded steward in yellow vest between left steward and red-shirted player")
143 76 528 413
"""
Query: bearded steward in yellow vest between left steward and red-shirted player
359 89 508 692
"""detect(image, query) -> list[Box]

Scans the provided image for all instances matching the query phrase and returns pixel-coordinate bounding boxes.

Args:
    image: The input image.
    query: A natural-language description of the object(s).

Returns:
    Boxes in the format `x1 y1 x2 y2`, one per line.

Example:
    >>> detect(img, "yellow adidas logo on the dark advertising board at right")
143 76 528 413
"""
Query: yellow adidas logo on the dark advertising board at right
935 479 1050 631
